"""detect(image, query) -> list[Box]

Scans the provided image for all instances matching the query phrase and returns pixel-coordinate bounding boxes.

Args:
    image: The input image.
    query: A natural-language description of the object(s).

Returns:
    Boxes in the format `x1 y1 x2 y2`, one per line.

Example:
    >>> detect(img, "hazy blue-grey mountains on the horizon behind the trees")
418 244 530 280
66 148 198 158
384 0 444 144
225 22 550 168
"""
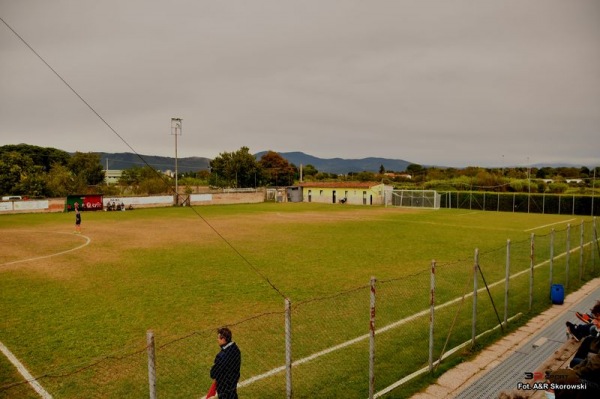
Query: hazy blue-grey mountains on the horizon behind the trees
99 151 418 174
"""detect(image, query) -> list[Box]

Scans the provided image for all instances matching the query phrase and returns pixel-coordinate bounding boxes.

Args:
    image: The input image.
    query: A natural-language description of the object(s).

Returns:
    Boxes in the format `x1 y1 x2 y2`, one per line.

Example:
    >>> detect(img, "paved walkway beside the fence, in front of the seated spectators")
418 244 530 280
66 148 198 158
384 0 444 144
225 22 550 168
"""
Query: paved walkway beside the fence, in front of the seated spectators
412 278 600 399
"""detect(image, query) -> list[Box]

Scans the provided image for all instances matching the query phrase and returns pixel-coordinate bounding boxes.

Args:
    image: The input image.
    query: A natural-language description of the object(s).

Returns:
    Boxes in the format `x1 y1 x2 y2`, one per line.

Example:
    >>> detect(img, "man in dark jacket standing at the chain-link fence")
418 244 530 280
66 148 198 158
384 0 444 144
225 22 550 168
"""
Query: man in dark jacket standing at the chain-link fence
210 327 242 399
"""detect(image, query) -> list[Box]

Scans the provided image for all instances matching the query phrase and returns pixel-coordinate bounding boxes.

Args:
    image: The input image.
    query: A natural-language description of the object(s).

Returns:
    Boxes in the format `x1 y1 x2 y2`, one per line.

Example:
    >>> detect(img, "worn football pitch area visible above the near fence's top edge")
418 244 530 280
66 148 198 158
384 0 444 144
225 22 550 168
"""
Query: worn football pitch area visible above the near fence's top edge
0 203 590 398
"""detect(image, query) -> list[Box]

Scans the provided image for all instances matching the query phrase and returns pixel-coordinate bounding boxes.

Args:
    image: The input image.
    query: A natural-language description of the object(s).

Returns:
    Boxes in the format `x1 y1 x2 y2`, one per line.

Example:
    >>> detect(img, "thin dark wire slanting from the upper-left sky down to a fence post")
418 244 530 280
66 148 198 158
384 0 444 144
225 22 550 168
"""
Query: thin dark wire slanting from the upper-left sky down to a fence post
0 17 286 298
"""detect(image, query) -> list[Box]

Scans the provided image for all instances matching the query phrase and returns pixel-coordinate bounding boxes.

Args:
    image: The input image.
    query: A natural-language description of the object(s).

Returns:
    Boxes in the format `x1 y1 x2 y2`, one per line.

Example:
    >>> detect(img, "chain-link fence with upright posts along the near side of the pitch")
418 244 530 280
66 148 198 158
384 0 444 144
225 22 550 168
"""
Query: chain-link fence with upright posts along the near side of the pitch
0 220 600 399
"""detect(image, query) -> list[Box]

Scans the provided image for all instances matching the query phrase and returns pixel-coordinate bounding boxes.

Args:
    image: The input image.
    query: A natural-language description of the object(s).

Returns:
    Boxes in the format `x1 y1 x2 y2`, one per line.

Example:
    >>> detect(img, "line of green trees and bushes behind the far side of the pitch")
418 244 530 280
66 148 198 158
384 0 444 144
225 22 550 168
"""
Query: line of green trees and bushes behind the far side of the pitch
0 144 600 198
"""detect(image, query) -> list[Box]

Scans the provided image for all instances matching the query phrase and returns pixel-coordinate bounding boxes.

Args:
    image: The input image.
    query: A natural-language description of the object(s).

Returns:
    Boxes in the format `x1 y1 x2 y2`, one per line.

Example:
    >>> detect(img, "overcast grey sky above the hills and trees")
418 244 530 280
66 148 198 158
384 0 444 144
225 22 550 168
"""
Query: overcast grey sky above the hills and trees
0 0 600 167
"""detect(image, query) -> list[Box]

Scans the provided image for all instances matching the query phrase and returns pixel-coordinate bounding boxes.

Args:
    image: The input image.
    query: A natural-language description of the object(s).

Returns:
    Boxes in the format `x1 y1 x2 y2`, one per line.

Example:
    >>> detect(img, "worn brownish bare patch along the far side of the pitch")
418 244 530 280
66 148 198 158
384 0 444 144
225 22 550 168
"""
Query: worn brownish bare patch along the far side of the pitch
0 208 417 278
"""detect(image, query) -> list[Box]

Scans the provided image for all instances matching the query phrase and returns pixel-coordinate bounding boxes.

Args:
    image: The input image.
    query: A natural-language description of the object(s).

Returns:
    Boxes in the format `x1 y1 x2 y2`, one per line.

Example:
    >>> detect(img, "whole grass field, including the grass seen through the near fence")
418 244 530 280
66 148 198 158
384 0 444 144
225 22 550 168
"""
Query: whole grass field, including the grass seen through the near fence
0 204 598 397
